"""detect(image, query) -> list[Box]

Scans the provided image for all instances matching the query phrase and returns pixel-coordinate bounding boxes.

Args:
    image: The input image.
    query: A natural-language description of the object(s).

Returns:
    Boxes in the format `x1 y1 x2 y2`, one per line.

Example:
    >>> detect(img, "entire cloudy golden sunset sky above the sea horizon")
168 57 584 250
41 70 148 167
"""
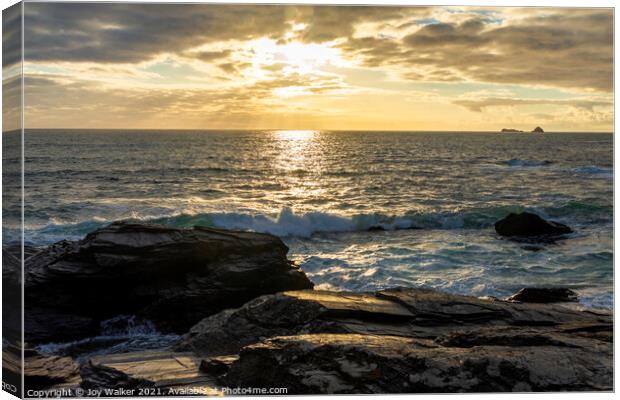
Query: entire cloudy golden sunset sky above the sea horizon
3 3 613 132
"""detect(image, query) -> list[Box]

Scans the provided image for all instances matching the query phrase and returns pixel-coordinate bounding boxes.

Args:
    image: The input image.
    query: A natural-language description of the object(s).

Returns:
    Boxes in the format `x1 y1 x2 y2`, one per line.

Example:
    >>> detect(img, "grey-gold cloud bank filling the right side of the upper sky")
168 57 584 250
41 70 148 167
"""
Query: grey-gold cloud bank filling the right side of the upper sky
342 9 613 92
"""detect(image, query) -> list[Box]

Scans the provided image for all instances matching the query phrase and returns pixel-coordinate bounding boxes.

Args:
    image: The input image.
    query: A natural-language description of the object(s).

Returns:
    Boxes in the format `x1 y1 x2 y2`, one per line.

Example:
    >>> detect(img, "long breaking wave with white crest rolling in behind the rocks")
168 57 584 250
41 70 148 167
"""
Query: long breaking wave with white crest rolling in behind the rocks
18 201 613 245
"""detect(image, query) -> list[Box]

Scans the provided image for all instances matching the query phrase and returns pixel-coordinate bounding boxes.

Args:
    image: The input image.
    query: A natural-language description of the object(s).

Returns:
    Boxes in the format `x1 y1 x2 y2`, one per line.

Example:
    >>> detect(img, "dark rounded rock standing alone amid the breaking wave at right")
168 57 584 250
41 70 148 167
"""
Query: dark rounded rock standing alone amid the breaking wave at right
495 212 573 237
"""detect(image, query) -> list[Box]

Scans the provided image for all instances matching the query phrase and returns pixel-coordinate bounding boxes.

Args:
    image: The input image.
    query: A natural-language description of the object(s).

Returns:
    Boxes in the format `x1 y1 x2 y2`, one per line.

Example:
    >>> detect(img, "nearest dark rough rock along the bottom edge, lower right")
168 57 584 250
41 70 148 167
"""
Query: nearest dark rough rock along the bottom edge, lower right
222 334 613 394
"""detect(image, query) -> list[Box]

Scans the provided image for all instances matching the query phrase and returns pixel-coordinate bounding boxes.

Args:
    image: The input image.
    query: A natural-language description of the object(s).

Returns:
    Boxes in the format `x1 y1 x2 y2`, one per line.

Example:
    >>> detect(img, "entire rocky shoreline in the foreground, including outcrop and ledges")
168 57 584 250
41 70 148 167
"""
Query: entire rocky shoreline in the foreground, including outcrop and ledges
3 221 613 396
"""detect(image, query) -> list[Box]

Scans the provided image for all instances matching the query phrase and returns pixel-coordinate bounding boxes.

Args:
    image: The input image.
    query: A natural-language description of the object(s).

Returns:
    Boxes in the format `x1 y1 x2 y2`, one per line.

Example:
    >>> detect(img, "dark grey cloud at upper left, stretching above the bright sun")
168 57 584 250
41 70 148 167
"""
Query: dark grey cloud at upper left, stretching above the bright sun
20 3 422 63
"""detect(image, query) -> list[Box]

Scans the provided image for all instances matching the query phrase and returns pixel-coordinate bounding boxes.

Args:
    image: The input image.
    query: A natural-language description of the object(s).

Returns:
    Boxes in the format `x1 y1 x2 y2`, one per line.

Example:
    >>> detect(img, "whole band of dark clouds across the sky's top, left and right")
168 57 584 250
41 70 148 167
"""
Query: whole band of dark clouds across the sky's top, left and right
19 3 613 92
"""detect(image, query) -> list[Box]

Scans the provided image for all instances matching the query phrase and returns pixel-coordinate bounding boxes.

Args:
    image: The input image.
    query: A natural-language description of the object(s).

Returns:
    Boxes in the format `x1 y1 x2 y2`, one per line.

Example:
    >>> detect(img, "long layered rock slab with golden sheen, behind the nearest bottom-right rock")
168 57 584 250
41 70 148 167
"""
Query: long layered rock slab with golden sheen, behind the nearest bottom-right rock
175 289 609 356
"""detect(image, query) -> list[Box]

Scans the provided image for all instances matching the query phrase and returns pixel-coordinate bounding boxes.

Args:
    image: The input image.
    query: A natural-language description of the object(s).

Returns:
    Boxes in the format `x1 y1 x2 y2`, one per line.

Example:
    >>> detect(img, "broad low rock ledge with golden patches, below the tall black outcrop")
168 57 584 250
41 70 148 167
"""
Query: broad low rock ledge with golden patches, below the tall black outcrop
76 288 613 395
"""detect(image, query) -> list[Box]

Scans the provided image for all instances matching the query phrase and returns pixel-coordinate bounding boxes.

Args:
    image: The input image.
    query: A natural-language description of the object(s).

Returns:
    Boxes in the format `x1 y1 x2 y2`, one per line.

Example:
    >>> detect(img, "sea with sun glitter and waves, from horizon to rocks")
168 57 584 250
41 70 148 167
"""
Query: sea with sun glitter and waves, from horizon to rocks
3 130 613 308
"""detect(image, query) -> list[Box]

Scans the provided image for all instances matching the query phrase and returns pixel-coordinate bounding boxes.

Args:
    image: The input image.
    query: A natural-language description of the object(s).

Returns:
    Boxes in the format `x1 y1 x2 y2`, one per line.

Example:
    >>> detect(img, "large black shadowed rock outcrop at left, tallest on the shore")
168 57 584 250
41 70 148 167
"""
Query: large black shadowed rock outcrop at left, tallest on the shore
17 223 312 342
